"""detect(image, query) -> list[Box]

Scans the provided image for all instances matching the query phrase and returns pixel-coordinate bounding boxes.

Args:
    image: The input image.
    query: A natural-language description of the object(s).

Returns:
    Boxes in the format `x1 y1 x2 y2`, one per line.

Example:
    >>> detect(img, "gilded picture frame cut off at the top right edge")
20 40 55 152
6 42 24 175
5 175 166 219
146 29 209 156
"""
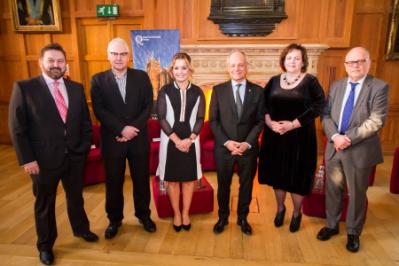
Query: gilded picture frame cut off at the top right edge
386 0 399 60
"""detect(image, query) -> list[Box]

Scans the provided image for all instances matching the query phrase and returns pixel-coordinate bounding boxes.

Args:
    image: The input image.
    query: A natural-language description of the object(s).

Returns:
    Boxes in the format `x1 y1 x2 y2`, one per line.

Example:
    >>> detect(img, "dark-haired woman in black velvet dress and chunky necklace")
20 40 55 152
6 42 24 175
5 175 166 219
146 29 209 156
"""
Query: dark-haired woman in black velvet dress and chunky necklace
258 44 325 232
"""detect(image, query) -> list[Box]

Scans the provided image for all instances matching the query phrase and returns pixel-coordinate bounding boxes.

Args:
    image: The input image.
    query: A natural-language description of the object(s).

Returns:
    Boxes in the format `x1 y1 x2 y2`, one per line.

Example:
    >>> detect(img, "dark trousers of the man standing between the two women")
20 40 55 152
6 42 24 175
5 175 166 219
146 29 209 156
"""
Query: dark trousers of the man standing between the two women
215 147 257 219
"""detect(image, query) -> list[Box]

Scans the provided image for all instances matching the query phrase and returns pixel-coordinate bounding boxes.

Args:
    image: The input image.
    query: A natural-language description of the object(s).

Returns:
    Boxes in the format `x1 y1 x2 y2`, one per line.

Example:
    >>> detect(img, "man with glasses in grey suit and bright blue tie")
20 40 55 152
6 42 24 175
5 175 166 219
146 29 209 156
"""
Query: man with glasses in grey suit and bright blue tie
317 47 388 252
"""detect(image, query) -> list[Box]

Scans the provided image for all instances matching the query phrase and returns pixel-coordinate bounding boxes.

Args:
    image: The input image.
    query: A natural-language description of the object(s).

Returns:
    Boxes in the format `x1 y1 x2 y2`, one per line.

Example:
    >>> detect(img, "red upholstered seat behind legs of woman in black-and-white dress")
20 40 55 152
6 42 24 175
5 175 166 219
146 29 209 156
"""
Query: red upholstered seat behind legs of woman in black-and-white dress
151 176 213 218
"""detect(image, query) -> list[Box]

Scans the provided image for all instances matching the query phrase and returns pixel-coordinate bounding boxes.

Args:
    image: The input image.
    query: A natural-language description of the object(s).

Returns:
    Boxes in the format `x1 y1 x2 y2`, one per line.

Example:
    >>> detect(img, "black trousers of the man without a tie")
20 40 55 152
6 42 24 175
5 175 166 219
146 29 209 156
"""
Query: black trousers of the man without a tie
104 147 151 223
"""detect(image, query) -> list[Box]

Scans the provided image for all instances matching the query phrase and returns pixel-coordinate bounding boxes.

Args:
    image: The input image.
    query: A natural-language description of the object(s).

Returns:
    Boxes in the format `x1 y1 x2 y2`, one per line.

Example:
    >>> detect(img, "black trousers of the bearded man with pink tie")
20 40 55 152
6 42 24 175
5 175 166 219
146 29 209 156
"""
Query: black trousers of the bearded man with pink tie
31 155 89 251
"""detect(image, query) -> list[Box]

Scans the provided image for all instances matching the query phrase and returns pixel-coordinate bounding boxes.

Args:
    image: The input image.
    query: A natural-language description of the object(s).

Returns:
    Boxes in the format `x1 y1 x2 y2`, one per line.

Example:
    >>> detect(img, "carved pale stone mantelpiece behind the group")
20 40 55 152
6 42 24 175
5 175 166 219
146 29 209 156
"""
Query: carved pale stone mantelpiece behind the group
181 44 328 85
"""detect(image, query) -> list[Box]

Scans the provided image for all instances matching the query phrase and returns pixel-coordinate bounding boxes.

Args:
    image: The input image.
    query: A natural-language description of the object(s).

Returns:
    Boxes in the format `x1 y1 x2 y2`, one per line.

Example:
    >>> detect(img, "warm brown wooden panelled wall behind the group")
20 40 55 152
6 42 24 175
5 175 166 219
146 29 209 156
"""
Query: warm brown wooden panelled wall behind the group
0 0 399 153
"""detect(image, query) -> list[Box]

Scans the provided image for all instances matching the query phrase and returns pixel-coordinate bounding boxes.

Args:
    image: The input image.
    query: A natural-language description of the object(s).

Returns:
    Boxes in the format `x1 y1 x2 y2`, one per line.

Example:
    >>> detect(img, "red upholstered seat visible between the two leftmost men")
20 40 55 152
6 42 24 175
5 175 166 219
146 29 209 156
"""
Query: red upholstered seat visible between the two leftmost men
83 125 105 185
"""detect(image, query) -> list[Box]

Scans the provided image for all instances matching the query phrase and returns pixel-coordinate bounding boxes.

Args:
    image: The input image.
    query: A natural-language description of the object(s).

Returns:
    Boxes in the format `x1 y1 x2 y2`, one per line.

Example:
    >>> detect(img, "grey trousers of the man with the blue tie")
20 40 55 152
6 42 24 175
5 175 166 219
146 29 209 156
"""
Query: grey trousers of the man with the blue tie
326 152 373 235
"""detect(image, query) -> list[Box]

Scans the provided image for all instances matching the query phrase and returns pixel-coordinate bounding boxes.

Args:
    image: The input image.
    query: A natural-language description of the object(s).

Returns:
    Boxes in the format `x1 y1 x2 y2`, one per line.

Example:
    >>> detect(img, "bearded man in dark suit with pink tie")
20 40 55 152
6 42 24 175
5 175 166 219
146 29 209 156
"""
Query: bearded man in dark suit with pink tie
9 44 98 265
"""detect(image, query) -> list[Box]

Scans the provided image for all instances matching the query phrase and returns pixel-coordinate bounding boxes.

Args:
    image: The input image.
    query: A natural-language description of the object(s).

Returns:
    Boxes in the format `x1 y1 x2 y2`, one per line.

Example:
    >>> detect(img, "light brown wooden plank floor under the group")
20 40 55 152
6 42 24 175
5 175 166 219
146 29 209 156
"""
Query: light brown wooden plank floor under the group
0 145 399 266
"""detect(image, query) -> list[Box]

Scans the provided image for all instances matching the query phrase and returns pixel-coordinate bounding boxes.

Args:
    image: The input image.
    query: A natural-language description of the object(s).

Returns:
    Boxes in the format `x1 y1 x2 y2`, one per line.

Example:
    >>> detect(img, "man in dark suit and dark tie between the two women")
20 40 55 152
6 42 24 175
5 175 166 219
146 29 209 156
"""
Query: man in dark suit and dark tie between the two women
209 51 264 235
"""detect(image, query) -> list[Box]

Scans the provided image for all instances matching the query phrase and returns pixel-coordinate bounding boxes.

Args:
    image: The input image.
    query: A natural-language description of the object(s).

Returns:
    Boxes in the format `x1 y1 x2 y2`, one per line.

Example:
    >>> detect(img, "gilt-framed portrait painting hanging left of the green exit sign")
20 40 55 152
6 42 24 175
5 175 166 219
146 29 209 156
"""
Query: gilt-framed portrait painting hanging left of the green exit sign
9 0 62 32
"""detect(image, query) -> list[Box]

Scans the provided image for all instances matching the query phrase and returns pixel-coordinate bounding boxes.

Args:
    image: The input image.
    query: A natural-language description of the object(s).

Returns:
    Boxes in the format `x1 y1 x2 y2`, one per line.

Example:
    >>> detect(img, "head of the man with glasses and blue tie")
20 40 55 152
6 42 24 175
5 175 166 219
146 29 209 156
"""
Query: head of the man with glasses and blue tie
345 47 370 82
